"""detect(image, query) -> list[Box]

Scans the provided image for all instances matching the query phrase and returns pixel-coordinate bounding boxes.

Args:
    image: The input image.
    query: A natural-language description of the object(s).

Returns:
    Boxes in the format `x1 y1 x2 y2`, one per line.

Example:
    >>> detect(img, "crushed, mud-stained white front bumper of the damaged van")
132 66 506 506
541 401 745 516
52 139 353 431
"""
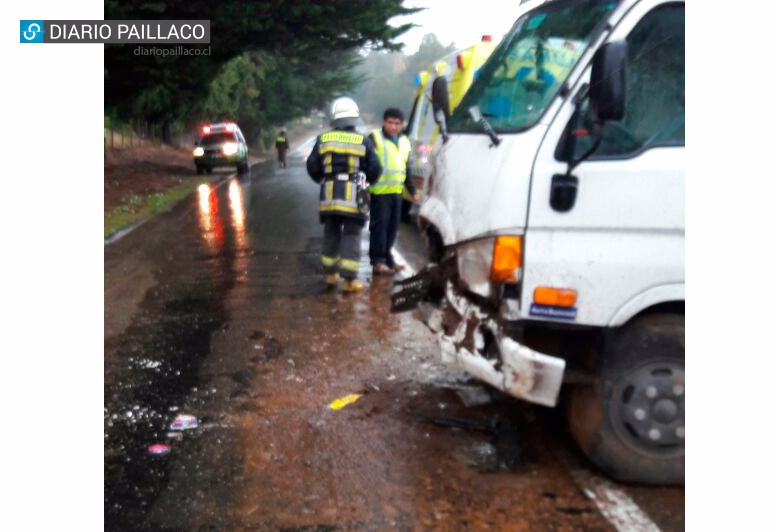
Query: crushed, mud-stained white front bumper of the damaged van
398 274 565 406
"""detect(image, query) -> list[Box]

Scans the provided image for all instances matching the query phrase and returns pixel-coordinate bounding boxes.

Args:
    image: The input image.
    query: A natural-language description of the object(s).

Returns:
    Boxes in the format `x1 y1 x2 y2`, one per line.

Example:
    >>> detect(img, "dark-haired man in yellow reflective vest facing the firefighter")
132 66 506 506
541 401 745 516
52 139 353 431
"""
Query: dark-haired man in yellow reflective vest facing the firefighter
368 107 419 275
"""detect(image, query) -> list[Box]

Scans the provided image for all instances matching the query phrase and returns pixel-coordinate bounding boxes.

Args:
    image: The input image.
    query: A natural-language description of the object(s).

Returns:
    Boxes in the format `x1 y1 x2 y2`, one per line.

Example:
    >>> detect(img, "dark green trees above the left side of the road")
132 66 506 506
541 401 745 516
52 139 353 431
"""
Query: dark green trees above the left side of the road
105 0 419 142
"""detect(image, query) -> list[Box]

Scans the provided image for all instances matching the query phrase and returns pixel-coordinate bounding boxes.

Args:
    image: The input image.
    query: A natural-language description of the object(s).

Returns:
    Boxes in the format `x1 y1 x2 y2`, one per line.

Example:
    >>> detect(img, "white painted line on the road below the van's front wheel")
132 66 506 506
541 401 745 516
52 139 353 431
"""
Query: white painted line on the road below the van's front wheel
570 469 661 532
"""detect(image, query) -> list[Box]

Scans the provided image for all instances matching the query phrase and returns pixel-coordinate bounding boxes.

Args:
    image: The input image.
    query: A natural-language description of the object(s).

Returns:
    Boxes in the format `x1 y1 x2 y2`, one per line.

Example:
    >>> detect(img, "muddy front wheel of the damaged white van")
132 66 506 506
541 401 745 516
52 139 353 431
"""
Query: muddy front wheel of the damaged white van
567 314 685 484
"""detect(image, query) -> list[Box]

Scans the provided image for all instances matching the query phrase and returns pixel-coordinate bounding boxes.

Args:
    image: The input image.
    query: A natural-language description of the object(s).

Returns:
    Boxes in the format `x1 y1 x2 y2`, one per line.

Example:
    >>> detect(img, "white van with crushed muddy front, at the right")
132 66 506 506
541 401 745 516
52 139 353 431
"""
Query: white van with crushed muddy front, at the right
393 0 685 483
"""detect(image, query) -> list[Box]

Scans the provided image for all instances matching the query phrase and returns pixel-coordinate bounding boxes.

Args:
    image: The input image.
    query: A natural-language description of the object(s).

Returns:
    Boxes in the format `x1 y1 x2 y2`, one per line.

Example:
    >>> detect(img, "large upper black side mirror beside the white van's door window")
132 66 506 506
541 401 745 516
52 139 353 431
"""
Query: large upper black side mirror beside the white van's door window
589 41 626 124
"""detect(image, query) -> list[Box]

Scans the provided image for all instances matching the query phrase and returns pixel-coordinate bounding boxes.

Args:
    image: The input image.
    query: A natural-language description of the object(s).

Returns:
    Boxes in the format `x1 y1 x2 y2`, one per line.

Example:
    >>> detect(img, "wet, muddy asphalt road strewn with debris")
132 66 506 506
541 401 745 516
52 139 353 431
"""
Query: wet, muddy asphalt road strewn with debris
104 152 684 530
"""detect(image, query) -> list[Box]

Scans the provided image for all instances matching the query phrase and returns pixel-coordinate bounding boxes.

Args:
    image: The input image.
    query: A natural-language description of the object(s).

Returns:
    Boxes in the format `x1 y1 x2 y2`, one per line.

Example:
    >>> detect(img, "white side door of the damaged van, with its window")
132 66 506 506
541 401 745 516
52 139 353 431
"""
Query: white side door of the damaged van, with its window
521 0 685 325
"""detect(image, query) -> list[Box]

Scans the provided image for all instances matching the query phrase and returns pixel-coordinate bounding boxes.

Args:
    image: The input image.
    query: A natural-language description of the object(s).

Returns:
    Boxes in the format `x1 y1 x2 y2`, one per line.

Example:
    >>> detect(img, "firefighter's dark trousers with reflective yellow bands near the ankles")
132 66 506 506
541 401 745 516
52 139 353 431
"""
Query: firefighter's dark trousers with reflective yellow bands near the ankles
322 214 364 279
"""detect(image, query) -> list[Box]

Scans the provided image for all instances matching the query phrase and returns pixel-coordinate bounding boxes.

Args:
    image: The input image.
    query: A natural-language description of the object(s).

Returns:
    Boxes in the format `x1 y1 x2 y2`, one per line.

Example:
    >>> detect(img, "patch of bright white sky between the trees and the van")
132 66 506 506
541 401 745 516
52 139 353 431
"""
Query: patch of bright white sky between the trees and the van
390 0 520 55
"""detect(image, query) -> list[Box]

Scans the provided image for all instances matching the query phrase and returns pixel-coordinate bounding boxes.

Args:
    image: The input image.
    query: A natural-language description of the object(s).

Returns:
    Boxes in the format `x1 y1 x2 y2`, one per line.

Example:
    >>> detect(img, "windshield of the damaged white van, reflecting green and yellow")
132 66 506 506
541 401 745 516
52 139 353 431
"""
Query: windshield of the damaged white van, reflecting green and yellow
449 0 619 133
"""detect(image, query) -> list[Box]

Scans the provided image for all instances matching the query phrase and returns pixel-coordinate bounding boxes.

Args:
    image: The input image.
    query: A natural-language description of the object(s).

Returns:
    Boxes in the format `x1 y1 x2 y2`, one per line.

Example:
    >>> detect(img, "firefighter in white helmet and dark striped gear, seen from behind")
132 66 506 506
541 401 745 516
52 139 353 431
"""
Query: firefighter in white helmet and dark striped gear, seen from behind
306 98 382 292
